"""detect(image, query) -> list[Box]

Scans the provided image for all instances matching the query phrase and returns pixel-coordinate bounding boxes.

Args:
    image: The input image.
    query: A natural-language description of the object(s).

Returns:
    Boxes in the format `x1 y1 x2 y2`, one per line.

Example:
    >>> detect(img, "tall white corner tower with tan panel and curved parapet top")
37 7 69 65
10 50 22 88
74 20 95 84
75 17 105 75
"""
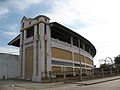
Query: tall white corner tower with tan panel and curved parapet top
20 15 51 82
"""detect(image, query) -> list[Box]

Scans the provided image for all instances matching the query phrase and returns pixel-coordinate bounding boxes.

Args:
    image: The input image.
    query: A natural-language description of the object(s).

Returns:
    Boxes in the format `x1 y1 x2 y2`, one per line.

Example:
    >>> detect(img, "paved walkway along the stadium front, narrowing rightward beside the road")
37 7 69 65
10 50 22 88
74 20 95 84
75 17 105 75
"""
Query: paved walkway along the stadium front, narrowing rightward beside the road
0 76 120 90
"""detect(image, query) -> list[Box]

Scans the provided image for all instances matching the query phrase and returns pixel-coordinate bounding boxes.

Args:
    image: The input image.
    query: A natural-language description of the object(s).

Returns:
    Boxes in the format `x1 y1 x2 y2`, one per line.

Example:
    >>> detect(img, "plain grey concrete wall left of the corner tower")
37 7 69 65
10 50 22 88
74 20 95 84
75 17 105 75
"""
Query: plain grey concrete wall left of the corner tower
0 53 21 79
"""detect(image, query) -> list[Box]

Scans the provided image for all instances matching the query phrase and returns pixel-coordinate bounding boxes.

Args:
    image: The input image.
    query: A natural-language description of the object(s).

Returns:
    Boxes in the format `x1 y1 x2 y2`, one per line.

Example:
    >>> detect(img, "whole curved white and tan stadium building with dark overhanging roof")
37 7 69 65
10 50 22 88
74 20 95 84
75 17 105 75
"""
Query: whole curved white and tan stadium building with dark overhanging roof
8 15 96 82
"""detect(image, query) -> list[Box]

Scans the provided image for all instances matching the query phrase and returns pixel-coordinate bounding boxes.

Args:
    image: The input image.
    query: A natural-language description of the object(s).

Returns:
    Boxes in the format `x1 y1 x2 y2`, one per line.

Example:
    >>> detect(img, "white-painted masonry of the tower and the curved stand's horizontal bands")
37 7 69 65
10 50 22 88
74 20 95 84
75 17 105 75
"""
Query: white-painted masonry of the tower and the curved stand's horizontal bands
20 15 96 82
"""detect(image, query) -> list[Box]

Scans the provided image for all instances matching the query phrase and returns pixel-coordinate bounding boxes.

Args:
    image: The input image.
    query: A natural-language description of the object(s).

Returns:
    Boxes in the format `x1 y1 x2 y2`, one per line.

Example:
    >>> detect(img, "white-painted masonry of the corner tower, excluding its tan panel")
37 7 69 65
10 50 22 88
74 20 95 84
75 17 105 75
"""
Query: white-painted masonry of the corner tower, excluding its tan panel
20 16 51 82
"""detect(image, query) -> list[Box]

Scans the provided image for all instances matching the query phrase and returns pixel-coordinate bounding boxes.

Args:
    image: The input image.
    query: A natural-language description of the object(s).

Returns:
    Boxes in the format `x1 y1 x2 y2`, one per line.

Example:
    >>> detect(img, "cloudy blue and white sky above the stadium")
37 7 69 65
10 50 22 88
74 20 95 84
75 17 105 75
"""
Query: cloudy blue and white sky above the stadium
0 0 120 66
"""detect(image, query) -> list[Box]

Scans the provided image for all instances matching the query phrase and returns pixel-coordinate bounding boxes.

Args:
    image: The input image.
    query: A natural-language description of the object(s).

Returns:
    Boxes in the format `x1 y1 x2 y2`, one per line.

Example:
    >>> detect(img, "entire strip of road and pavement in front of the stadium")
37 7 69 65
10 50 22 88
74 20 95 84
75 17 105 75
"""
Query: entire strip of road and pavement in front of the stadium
0 79 120 90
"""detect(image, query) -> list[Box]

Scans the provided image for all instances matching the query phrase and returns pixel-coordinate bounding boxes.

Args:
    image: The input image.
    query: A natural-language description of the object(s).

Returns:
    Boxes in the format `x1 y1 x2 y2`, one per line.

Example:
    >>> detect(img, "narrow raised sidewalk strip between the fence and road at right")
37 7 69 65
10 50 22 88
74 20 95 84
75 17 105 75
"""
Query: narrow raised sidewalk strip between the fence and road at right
74 76 120 86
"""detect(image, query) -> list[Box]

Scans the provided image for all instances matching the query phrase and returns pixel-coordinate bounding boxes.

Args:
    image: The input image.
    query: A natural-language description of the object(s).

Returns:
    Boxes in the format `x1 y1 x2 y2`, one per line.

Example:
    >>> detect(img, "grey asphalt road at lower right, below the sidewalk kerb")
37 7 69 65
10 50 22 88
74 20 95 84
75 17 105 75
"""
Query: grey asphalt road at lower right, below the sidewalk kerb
50 79 120 90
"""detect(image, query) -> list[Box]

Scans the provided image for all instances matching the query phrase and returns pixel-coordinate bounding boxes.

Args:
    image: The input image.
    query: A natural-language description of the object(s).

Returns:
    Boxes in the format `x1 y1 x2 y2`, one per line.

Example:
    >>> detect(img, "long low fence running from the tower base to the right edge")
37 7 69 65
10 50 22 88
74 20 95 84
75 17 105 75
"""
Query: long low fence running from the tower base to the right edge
42 69 119 82
